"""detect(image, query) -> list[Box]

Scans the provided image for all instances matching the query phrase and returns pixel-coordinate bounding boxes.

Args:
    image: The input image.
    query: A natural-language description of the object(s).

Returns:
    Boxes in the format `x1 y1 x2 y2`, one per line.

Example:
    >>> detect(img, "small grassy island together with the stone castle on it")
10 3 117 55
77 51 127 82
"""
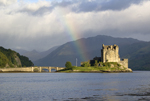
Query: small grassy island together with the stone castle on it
57 44 132 73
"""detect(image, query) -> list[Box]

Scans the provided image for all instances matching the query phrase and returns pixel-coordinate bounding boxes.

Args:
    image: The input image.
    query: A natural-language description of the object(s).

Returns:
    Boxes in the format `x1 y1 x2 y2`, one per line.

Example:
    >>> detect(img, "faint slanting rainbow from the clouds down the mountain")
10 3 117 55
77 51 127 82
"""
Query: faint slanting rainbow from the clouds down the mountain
57 11 89 61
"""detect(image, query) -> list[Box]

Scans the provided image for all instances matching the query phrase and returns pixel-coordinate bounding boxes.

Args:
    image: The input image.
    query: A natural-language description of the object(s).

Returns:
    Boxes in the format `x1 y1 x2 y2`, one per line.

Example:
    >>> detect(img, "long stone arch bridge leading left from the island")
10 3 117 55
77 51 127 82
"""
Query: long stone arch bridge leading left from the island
0 67 64 72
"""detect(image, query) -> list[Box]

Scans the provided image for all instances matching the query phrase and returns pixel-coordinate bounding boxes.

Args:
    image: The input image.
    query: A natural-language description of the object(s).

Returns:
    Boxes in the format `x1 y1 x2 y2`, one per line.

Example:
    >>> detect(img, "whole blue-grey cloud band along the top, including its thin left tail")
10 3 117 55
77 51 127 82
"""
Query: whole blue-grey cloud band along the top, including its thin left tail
20 0 143 15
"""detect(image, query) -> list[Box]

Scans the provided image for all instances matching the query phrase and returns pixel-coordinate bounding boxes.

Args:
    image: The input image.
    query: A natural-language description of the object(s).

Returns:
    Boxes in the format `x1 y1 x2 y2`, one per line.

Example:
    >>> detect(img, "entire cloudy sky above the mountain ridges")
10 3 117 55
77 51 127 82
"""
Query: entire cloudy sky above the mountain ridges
0 0 150 51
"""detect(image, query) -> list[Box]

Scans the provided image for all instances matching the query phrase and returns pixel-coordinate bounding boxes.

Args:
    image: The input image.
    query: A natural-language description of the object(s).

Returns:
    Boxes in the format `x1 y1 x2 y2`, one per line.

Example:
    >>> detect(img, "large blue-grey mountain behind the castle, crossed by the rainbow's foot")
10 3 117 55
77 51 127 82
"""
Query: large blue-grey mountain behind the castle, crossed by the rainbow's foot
34 35 144 67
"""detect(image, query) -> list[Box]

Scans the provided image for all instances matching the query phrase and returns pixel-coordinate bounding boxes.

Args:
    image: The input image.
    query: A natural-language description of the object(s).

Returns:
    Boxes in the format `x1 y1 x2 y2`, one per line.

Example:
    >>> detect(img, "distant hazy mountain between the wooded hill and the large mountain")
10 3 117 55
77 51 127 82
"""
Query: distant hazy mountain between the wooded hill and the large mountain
15 46 58 61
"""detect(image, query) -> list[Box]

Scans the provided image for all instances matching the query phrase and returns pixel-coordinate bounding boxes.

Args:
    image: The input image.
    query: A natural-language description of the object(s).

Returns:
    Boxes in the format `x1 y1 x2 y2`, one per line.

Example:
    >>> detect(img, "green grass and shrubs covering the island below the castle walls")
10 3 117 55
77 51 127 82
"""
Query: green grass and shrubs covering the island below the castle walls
58 61 132 72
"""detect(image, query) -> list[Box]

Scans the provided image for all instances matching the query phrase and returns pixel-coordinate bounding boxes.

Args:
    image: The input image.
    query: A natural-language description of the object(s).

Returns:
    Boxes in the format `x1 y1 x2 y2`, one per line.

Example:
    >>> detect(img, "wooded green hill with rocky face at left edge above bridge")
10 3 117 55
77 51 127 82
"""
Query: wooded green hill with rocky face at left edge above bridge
0 47 33 68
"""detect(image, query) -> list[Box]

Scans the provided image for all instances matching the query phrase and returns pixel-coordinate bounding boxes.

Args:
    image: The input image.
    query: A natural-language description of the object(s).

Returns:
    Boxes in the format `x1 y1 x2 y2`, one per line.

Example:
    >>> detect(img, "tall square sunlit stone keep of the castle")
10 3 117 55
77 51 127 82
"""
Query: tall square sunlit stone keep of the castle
101 44 120 62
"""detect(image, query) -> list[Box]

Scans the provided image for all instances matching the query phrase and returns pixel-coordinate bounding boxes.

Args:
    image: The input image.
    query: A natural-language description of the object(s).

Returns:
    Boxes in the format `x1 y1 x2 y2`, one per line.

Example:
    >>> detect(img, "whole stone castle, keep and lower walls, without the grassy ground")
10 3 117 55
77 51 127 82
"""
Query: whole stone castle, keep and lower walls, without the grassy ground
81 44 128 69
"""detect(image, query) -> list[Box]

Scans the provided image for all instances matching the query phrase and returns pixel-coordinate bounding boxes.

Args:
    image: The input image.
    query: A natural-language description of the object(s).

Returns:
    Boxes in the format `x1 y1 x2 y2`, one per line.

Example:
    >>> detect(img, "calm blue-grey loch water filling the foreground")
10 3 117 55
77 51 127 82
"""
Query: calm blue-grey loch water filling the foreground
0 71 150 101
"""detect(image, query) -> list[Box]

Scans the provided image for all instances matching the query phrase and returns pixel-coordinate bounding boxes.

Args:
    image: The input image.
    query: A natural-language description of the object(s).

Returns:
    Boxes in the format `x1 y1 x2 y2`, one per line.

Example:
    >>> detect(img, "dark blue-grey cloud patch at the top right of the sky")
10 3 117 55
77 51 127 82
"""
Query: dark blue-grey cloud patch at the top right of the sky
73 0 143 12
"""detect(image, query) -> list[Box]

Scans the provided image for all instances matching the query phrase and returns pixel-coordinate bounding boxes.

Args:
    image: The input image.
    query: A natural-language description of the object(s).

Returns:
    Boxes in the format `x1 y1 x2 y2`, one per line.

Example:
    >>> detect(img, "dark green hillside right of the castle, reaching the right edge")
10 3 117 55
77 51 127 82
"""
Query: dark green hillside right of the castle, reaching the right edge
120 42 150 70
